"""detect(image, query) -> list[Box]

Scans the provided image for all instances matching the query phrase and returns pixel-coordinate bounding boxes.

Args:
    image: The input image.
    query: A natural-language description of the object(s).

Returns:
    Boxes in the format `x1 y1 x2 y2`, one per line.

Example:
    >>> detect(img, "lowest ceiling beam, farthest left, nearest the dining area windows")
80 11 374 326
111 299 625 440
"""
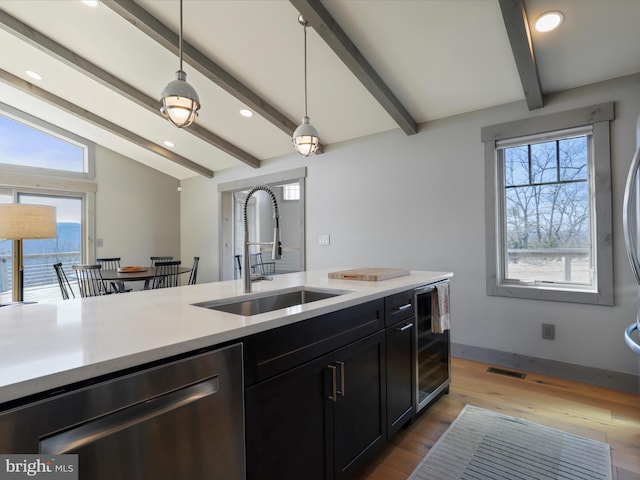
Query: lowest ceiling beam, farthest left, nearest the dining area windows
0 69 213 178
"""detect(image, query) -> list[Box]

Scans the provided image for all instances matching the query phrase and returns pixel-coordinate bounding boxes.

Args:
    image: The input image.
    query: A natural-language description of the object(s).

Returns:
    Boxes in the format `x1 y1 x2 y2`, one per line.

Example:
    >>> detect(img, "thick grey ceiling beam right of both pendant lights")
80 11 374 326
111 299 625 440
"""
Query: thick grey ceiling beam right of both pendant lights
289 0 418 135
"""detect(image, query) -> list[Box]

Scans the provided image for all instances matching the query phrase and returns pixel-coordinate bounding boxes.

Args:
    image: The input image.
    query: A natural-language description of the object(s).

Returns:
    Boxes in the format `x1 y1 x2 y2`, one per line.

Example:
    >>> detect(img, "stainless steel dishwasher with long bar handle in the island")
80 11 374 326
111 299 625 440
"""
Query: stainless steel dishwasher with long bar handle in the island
0 344 245 480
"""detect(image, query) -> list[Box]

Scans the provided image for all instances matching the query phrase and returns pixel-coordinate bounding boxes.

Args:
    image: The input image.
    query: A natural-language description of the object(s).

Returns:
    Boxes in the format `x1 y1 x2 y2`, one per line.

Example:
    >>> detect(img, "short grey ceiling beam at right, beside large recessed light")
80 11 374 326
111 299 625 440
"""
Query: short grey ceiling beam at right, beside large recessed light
500 0 544 110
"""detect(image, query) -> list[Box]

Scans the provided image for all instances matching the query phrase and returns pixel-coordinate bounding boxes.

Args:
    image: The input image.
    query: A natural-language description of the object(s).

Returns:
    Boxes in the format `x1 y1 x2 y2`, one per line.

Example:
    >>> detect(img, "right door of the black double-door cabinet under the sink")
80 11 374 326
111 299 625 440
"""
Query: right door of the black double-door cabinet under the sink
330 331 387 479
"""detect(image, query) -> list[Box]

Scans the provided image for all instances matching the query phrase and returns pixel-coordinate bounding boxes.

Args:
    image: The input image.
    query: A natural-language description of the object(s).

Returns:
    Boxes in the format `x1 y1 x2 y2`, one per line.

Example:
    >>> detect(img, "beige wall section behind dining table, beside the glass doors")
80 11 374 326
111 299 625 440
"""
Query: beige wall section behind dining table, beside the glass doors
95 146 180 266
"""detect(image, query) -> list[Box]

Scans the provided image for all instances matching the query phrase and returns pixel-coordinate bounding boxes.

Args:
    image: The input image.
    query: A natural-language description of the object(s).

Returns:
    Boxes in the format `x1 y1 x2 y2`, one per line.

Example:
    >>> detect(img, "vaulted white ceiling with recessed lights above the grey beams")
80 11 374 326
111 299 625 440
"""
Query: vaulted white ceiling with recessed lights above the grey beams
0 0 640 179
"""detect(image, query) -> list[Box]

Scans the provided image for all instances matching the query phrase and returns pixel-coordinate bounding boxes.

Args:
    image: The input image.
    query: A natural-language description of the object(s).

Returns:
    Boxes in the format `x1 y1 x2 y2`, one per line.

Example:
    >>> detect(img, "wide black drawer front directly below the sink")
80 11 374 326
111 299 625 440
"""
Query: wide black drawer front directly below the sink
244 299 384 386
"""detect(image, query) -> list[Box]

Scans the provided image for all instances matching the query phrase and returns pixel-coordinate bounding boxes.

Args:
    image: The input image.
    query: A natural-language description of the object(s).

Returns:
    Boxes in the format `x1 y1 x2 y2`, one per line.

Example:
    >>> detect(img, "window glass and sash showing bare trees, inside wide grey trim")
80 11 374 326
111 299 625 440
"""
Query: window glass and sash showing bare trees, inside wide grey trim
497 130 596 289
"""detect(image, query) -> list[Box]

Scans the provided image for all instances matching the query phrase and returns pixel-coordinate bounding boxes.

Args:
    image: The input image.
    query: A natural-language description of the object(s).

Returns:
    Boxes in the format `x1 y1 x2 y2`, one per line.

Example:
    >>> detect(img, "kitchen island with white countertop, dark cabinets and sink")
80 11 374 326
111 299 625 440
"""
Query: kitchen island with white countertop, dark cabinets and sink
0 270 452 480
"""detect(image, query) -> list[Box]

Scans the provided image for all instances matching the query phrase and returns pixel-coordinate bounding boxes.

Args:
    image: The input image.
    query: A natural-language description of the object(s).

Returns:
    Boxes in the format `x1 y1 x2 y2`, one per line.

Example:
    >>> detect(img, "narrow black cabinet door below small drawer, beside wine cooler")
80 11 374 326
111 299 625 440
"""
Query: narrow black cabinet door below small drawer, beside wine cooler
386 320 415 438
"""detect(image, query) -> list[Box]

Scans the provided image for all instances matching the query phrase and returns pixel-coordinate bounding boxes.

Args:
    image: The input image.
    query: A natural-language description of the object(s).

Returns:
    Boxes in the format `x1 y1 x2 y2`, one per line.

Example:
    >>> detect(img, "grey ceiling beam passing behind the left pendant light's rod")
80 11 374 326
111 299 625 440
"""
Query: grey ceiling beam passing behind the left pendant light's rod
101 0 298 136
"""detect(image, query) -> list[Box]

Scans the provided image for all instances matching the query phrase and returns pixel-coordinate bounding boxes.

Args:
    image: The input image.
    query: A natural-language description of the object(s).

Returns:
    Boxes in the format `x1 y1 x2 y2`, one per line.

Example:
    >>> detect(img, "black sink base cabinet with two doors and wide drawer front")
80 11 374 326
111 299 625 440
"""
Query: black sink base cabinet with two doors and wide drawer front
245 300 386 480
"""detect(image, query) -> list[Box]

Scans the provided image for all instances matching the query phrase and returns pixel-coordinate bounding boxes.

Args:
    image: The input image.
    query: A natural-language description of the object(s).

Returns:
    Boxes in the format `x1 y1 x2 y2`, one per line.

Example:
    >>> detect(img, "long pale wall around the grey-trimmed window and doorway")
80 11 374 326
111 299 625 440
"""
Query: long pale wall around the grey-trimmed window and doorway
181 76 640 374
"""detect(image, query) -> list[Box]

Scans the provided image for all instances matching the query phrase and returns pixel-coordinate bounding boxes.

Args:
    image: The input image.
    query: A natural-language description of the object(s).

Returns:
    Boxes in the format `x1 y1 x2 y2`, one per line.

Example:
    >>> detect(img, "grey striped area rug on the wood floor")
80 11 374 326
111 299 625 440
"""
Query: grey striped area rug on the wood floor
409 405 612 480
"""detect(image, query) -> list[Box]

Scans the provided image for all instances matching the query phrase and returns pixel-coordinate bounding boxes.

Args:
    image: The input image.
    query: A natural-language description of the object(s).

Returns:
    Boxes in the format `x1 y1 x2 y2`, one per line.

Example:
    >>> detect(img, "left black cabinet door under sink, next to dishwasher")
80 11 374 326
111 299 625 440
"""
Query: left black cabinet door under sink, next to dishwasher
245 355 333 480
